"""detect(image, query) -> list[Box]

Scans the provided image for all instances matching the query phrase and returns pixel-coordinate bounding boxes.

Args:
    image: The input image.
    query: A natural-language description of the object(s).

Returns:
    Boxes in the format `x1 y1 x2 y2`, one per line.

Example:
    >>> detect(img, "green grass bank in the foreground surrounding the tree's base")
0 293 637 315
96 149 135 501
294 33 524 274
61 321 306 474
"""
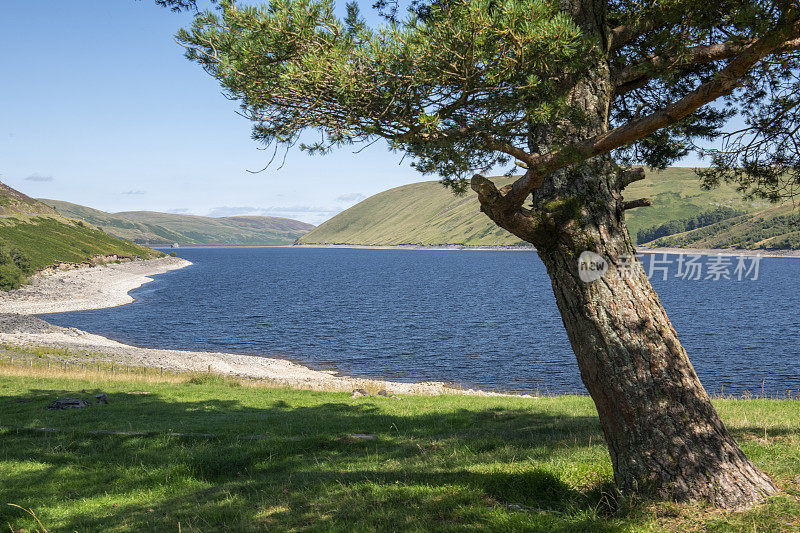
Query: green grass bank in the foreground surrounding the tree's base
0 364 800 531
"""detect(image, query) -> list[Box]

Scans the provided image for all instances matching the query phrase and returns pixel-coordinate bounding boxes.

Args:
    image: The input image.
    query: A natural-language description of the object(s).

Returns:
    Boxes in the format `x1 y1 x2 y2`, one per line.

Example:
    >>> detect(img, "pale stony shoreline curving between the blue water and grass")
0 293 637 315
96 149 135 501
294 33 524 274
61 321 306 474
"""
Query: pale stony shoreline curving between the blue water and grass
0 257 532 397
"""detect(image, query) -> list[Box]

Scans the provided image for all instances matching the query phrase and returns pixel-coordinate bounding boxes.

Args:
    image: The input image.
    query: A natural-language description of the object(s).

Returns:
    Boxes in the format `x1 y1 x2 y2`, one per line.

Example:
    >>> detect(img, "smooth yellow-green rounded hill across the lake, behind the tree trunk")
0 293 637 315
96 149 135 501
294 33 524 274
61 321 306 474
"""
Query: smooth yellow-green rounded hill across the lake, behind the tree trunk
299 168 780 246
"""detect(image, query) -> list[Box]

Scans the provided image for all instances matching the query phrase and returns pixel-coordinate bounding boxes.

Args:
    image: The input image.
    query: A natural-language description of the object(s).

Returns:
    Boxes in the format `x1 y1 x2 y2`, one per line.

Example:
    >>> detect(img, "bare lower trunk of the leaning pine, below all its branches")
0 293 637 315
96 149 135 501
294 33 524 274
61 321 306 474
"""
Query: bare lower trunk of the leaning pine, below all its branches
539 188 776 508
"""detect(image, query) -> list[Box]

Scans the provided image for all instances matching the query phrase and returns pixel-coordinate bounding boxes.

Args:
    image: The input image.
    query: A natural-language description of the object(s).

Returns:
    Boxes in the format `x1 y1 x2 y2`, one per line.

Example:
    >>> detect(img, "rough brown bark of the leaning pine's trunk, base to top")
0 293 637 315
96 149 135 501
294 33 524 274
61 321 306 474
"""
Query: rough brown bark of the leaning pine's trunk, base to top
472 0 777 508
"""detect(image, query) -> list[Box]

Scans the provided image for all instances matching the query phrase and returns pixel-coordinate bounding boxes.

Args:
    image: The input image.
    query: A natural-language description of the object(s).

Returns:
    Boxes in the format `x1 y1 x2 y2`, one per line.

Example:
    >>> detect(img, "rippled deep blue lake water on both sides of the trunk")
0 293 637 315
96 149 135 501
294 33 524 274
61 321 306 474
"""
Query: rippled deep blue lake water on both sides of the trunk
43 248 800 395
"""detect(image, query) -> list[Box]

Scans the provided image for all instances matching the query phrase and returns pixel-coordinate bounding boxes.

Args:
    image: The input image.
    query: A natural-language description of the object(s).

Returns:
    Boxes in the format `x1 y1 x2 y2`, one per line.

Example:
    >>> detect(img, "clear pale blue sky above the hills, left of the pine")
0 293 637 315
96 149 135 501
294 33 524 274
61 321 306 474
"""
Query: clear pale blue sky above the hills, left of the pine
0 0 690 224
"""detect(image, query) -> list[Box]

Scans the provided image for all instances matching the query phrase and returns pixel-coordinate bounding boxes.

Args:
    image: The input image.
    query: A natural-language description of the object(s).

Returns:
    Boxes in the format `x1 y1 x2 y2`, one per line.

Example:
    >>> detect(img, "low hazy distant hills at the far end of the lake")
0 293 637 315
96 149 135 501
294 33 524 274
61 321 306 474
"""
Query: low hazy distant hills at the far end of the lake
42 199 314 245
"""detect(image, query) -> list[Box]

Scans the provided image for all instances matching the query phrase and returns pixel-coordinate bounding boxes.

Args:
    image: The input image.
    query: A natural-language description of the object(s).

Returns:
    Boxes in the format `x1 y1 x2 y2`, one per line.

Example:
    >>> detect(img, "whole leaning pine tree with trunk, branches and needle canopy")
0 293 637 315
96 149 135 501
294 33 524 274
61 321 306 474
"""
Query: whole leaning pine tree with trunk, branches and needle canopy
178 0 800 508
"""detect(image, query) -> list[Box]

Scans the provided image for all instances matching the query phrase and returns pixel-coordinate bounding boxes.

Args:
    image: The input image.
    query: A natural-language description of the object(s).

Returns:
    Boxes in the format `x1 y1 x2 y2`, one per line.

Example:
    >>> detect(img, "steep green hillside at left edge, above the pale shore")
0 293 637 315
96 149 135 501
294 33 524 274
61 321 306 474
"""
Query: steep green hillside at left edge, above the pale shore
0 184 163 290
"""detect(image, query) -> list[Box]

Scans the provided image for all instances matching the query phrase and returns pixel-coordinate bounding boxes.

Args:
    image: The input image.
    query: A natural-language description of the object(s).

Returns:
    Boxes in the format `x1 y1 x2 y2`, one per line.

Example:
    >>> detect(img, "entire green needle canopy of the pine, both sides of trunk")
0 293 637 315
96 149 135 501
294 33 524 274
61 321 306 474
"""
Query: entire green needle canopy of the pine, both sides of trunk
178 0 800 201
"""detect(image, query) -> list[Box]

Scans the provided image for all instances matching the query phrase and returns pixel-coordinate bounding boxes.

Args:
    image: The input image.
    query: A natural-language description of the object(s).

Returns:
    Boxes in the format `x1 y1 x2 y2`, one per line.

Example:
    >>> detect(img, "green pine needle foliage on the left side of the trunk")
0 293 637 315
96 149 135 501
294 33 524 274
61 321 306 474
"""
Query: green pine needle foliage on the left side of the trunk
178 0 588 187
